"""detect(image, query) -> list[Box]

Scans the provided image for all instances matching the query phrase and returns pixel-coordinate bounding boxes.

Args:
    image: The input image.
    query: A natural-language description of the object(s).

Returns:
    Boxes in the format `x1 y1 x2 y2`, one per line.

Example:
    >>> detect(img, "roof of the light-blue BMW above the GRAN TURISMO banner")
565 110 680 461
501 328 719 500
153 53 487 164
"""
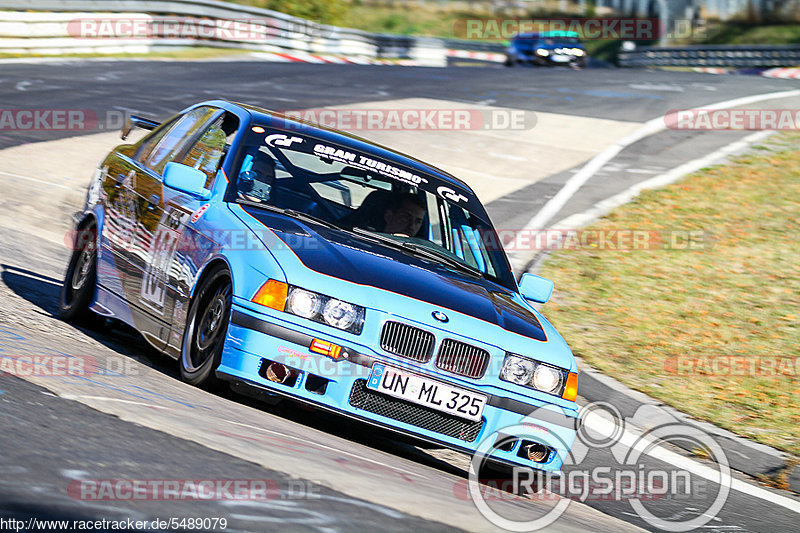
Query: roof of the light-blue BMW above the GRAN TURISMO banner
203 100 480 197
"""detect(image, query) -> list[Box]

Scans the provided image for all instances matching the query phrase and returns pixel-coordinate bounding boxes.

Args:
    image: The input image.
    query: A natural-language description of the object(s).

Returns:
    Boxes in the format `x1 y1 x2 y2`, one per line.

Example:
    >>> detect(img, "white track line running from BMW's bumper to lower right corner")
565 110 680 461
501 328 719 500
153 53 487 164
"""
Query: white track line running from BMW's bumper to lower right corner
582 416 800 513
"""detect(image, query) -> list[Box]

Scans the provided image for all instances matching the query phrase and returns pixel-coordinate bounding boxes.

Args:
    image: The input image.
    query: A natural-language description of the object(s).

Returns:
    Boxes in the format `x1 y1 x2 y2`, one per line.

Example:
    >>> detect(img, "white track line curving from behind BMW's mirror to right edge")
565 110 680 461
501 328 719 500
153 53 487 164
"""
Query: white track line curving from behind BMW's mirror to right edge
513 89 800 258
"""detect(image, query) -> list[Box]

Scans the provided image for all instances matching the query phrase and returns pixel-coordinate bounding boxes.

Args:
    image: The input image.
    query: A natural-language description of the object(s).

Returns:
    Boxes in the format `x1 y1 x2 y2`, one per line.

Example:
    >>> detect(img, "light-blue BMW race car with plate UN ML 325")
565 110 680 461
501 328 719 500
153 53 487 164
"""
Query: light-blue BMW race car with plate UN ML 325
60 100 578 470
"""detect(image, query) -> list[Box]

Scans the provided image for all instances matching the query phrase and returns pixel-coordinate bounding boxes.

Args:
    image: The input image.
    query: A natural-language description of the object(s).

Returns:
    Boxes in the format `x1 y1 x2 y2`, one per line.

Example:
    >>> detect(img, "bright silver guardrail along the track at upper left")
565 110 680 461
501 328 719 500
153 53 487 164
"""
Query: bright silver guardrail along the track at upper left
0 0 447 66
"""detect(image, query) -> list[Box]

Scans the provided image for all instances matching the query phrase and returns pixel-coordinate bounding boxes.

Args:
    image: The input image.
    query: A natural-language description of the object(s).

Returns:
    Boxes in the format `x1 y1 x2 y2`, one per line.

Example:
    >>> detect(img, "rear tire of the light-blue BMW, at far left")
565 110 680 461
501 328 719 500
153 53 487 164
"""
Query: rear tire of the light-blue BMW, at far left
58 222 97 322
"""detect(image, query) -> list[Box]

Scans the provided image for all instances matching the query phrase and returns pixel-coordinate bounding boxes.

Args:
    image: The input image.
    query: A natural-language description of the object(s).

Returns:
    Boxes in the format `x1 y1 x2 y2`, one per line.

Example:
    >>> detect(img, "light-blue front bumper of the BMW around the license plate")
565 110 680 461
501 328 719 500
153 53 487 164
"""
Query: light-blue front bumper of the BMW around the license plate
217 305 578 471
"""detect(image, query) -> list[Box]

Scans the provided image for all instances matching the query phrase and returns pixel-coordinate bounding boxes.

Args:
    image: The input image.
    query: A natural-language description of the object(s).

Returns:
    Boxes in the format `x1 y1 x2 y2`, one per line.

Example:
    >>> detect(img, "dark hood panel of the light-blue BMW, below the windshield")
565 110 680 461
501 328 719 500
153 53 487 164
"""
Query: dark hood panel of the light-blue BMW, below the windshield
242 206 547 341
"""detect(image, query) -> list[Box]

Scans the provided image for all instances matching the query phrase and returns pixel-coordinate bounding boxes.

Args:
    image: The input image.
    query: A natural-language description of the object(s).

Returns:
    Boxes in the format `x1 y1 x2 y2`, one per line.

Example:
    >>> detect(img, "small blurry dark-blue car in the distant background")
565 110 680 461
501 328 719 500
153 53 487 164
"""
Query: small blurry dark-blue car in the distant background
505 31 589 68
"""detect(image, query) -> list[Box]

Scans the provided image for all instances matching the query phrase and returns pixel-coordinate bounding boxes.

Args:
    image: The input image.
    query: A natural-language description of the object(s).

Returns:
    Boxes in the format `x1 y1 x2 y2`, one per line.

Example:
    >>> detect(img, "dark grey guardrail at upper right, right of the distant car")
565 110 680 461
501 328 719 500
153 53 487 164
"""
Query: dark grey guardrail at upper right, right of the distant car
618 45 800 67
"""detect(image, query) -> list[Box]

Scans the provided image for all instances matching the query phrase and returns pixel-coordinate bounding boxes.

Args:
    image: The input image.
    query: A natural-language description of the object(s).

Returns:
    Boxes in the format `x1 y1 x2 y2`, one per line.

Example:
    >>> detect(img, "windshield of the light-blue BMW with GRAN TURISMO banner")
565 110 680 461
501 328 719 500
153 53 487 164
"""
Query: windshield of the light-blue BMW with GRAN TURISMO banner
235 126 515 288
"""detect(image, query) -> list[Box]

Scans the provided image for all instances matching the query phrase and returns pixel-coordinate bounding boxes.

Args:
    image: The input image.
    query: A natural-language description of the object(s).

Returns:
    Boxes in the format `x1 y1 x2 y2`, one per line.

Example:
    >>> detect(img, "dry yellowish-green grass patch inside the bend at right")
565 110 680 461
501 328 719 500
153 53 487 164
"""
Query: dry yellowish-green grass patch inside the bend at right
542 133 800 455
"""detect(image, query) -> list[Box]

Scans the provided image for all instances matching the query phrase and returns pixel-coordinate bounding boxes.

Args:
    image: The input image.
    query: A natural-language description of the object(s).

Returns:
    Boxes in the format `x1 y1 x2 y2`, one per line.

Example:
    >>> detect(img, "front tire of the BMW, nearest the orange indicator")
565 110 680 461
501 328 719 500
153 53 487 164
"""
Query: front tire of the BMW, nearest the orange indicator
180 267 233 389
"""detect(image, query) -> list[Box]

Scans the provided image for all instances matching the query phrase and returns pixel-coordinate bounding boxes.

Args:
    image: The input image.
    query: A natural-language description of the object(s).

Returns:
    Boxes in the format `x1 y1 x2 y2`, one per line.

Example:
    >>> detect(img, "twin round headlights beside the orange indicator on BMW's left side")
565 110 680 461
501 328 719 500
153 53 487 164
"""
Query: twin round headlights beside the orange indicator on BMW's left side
284 286 365 335
